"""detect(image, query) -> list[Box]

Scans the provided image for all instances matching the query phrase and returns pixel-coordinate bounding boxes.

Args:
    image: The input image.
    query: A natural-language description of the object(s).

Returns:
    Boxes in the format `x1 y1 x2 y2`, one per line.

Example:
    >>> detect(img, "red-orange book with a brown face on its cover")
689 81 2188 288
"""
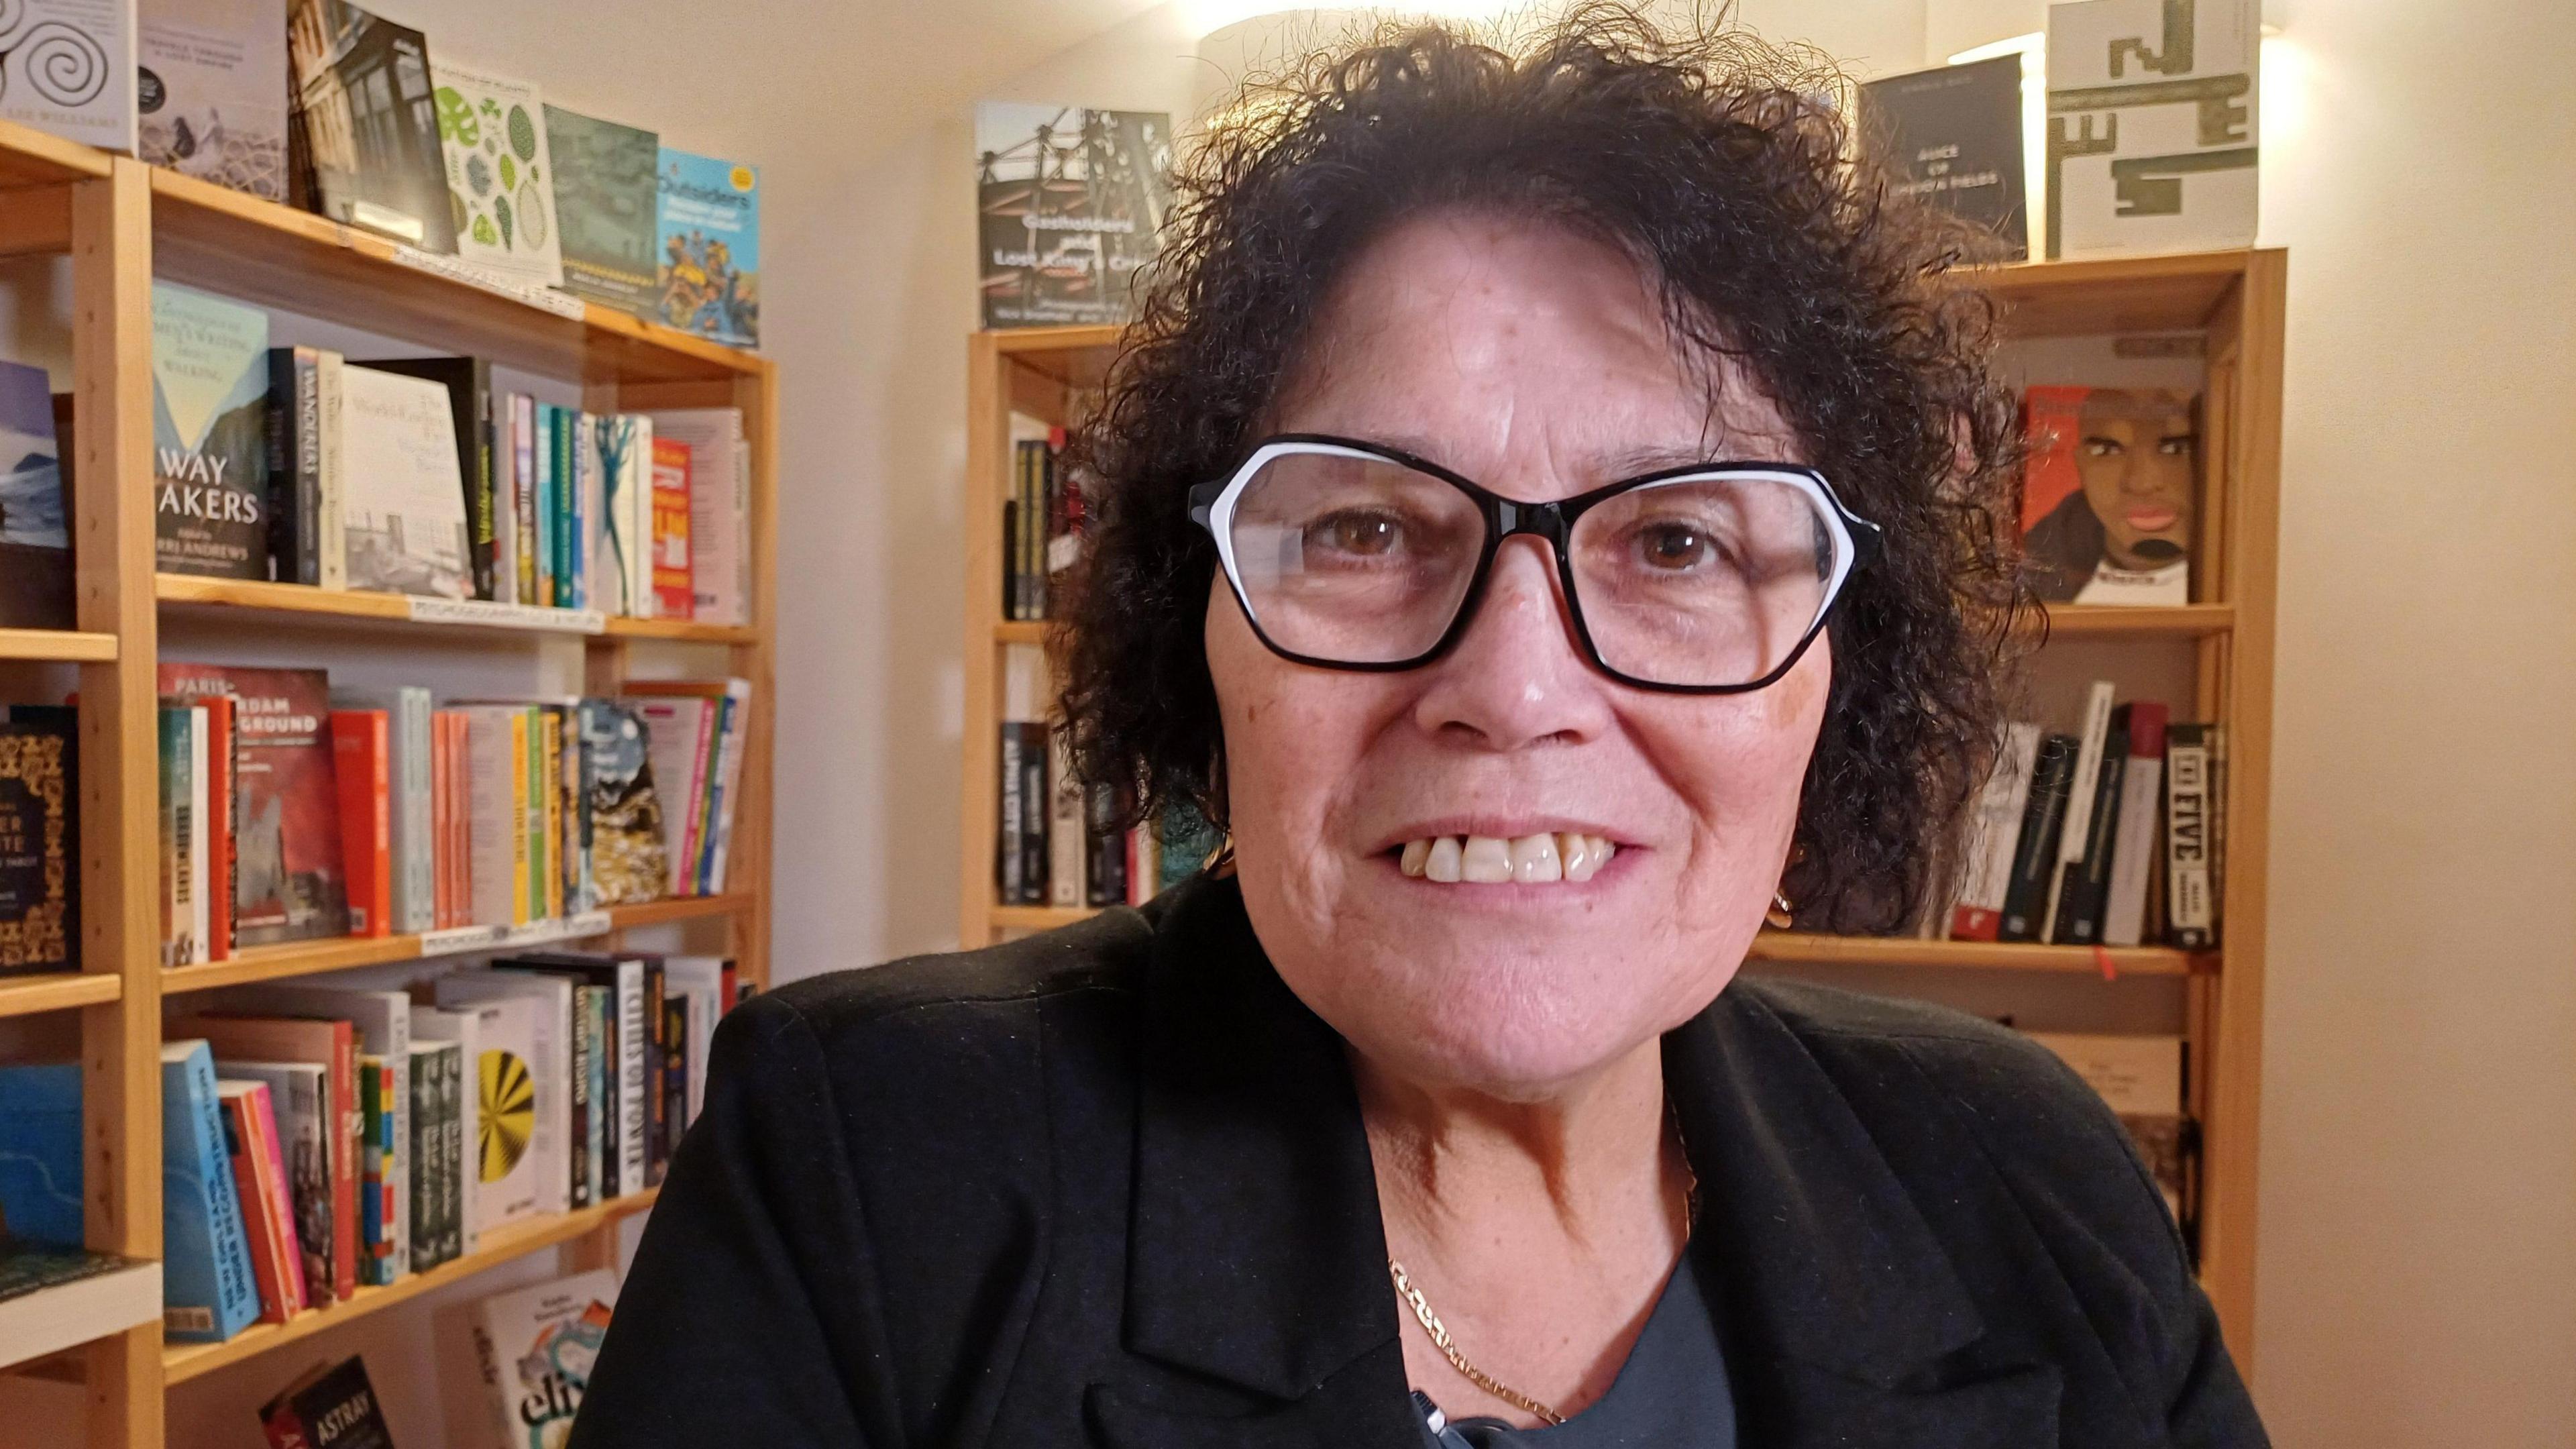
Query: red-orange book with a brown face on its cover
2022 387 2200 606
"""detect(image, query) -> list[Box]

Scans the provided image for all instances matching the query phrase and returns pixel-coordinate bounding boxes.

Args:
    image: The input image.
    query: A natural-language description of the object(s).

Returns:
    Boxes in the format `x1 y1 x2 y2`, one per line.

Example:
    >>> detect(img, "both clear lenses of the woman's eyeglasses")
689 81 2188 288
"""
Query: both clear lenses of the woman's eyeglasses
1229 451 1834 686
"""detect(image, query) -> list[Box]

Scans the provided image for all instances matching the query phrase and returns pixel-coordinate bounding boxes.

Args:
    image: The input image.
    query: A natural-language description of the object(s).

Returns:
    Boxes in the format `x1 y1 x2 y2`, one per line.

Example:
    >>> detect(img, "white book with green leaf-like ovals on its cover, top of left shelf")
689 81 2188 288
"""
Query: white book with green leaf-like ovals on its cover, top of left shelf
435 62 564 286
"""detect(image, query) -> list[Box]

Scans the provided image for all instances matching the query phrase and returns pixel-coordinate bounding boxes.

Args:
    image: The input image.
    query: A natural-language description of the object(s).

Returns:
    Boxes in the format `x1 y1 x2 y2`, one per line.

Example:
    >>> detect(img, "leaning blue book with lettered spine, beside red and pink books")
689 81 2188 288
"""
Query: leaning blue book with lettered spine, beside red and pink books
162 1042 260 1343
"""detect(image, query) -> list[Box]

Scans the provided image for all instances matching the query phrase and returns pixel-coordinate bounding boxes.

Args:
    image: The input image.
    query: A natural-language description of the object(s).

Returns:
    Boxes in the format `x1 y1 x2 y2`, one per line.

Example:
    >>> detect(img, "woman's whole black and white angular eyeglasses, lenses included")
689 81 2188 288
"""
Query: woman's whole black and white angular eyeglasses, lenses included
1190 433 1880 694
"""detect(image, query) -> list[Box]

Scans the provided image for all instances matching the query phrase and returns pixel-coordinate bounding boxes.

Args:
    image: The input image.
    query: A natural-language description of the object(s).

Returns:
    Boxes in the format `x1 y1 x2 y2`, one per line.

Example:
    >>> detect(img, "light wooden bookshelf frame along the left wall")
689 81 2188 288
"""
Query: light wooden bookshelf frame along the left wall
0 123 778 1449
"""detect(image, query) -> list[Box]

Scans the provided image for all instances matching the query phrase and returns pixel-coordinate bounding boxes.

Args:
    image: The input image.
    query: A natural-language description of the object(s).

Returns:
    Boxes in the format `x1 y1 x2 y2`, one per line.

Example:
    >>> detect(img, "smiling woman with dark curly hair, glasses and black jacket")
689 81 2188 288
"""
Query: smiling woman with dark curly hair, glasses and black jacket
574 10 2262 1449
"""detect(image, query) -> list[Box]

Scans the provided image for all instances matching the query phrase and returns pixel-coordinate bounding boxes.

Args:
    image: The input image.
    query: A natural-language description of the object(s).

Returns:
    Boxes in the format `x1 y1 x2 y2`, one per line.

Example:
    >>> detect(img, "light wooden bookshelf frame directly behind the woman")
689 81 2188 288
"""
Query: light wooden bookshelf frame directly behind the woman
958 250 2288 1372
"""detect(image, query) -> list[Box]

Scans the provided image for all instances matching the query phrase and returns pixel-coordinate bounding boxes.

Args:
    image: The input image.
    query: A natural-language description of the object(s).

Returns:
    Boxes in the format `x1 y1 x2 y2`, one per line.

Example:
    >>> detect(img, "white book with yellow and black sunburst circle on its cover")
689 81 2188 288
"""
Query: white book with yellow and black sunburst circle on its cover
435 969 572 1217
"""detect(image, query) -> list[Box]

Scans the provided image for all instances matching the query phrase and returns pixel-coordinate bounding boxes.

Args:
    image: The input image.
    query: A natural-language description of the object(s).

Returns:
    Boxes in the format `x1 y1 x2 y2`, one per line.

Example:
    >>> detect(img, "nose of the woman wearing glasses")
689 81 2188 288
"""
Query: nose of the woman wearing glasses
1414 536 1610 750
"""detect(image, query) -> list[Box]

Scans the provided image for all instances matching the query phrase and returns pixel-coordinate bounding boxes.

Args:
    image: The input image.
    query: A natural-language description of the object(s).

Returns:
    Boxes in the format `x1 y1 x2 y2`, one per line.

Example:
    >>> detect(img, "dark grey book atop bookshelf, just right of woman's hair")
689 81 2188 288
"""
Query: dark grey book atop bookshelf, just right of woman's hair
1860 54 2030 260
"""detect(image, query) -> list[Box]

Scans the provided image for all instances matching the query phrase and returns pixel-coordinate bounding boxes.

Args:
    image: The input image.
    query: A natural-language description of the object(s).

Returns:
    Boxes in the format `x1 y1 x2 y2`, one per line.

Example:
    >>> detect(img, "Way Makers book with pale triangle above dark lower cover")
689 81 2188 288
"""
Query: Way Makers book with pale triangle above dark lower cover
152 281 268 578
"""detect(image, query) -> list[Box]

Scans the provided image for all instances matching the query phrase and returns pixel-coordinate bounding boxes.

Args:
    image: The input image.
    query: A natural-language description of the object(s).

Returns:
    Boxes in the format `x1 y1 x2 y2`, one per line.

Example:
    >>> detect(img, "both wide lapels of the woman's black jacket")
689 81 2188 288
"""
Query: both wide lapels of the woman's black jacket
1126 877 1984 1400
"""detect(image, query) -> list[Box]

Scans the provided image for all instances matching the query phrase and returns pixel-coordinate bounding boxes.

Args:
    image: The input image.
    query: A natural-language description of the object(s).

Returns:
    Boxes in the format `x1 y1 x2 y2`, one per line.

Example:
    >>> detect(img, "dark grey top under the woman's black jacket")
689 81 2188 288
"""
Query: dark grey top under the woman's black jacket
1414 1253 1736 1449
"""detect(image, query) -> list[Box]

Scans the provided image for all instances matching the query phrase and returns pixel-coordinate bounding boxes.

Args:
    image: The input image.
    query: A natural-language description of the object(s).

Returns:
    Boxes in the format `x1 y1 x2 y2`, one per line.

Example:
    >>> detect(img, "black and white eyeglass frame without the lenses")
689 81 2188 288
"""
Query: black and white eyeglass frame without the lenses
1190 433 1886 694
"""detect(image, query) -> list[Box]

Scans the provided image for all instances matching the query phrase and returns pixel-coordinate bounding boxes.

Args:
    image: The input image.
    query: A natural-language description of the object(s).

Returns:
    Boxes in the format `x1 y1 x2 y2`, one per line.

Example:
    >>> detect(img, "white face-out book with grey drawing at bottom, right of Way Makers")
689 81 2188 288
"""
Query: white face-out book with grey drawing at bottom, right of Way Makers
340 364 474 598
